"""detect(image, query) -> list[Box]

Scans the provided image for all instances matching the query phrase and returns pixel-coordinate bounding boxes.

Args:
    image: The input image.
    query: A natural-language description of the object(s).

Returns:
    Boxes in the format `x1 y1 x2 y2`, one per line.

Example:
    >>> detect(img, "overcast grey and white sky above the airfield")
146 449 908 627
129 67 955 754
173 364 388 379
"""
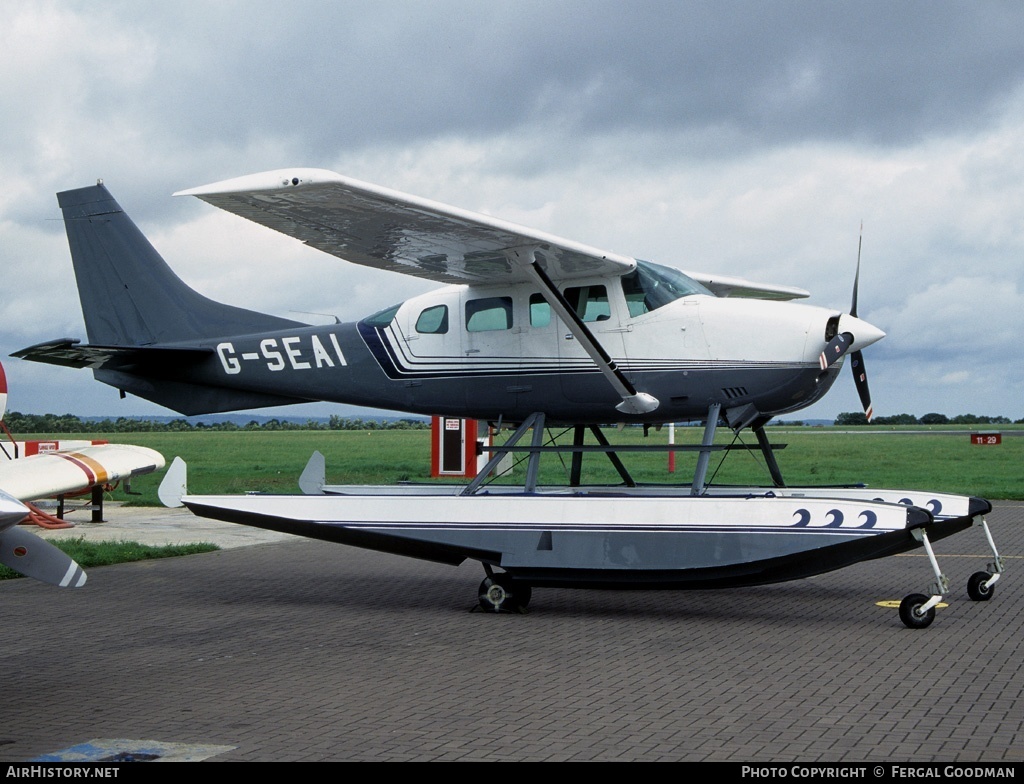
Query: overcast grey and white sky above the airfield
0 0 1024 420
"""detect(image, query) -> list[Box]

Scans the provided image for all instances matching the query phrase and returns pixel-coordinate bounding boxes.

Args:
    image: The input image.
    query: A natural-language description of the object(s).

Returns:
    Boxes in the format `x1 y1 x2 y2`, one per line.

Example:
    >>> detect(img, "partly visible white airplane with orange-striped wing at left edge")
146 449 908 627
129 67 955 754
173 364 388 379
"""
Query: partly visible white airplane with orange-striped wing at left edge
0 365 164 587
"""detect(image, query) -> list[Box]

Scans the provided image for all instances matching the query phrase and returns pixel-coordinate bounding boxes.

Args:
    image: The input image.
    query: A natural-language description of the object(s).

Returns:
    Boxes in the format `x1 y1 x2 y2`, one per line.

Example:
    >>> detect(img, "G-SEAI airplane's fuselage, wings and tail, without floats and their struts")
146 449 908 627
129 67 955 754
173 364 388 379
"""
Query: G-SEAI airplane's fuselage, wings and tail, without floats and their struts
14 170 883 427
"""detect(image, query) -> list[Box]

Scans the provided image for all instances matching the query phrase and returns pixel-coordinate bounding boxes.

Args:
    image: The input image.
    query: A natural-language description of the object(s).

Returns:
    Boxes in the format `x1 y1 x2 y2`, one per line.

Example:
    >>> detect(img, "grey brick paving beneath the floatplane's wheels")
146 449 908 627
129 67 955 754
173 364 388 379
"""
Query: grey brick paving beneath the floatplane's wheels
0 503 1024 763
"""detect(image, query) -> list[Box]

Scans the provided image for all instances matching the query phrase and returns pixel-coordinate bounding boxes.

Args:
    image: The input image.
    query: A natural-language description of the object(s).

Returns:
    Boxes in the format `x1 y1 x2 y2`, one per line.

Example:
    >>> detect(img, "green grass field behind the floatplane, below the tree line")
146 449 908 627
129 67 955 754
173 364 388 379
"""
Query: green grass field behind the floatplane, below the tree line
18 426 1024 506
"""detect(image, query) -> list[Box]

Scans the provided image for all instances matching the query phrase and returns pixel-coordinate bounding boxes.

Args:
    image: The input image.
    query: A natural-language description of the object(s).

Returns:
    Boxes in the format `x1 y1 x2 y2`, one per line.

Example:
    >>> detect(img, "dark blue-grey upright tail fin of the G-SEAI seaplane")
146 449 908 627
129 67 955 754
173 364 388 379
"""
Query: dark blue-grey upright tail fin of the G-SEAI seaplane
57 183 302 346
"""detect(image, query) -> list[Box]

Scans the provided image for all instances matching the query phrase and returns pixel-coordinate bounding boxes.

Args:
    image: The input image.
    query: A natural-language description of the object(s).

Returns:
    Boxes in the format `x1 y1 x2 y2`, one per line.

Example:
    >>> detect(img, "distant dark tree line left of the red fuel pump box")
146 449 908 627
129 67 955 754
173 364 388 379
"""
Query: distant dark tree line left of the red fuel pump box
4 411 430 436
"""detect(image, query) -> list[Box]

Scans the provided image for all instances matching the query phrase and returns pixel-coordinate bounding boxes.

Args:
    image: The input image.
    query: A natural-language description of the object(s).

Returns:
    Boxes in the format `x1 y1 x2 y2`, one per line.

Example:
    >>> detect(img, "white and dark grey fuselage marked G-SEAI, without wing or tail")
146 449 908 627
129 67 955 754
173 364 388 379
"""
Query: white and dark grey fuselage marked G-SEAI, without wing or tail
138 264 881 423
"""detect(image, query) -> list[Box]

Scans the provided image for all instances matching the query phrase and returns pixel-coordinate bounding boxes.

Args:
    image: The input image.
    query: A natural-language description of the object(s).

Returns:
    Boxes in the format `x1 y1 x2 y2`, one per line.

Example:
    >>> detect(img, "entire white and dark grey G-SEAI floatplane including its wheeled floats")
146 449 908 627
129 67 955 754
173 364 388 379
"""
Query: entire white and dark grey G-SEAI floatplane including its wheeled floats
14 169 1002 627
